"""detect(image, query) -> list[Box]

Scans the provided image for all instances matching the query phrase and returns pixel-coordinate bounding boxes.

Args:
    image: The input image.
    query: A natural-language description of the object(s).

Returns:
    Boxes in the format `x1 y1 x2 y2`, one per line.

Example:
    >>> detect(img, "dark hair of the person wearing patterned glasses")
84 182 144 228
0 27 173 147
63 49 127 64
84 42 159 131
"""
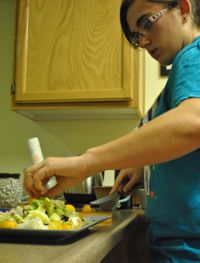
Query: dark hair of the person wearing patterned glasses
120 0 200 47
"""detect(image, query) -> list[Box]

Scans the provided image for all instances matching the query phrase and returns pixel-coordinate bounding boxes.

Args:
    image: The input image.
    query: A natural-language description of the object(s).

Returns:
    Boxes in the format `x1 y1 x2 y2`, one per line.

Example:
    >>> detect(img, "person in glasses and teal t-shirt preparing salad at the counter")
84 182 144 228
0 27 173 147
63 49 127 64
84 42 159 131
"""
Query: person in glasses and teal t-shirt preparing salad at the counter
24 0 200 263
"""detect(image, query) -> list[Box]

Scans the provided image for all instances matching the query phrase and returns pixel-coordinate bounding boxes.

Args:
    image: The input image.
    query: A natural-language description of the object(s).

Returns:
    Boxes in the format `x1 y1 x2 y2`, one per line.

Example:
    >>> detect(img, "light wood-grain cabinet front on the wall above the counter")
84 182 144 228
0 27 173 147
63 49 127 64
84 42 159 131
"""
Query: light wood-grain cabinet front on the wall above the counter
15 0 135 103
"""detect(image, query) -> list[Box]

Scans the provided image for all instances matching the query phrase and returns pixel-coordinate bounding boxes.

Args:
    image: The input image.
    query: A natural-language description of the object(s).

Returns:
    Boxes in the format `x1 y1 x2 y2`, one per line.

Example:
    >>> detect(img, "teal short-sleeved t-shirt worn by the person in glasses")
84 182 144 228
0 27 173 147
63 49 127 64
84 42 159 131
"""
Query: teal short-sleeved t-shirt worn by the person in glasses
146 36 200 238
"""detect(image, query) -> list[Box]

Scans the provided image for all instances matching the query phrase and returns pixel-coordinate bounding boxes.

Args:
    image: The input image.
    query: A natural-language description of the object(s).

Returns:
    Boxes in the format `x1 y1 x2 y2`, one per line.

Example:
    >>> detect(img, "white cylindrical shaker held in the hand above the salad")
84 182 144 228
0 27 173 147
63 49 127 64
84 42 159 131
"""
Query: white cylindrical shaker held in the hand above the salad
28 137 57 189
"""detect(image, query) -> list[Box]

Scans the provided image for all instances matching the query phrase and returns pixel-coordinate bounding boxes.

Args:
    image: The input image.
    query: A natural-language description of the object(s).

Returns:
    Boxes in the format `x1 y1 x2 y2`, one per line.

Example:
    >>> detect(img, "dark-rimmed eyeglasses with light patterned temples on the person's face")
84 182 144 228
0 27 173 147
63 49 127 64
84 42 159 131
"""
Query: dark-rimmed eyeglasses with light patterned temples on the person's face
129 7 172 48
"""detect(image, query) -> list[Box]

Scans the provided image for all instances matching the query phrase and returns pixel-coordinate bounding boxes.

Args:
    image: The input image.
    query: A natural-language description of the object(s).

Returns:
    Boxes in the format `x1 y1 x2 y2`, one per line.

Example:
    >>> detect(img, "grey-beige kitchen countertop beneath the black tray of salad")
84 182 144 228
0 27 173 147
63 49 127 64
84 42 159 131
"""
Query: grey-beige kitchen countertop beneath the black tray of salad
0 210 147 263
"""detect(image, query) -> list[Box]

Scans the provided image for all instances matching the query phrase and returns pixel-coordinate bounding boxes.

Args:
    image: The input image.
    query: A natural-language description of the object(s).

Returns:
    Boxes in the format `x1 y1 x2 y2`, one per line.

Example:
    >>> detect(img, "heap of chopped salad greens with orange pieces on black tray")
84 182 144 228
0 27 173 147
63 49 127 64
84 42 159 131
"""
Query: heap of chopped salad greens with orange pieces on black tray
0 197 89 230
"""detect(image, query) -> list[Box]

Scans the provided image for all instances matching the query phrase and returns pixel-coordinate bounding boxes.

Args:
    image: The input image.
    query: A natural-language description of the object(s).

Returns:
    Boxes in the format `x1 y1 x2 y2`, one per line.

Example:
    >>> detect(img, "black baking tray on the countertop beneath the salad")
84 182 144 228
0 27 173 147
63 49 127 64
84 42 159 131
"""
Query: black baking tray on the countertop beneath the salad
0 215 111 245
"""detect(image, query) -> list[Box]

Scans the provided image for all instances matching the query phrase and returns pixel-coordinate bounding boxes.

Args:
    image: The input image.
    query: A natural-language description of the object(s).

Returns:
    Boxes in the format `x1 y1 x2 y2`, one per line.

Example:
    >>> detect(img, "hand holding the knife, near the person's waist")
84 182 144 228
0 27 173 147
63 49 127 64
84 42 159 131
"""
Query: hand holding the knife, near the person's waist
110 167 144 194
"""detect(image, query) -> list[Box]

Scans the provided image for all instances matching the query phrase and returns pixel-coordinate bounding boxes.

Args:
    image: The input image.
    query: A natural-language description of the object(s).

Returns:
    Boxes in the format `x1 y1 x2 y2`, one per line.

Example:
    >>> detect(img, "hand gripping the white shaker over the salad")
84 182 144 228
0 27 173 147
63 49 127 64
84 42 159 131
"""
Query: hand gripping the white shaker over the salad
24 156 87 197
